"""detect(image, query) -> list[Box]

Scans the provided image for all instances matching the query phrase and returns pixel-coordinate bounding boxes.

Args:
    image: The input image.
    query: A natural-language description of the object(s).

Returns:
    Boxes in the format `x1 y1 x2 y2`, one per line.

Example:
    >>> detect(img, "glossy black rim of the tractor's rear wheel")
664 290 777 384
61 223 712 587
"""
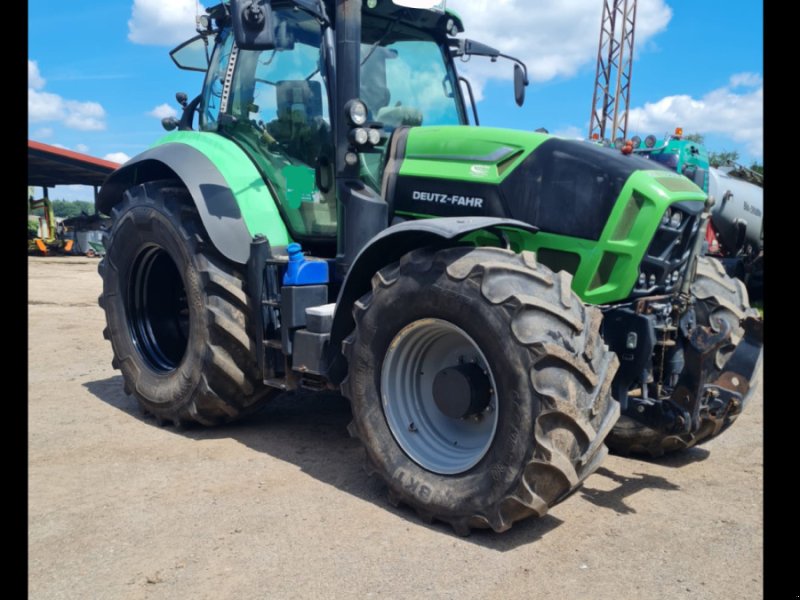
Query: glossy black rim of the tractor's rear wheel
127 246 189 373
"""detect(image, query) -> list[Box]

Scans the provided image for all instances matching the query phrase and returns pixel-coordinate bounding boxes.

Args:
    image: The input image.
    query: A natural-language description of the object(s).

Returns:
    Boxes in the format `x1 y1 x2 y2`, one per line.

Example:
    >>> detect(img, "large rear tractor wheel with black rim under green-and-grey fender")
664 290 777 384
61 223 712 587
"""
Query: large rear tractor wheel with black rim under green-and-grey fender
98 181 270 425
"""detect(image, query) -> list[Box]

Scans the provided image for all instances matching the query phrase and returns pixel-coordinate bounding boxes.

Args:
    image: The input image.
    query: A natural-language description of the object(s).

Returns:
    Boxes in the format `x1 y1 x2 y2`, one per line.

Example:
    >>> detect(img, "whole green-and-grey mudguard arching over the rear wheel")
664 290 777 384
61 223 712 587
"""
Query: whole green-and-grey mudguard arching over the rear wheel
97 132 291 264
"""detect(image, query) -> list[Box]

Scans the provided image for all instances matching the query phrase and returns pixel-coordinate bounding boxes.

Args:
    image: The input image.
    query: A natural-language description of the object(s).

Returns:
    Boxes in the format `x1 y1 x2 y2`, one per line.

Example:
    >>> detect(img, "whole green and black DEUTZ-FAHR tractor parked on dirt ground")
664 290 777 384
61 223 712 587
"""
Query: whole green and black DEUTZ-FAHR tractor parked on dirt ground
97 0 762 534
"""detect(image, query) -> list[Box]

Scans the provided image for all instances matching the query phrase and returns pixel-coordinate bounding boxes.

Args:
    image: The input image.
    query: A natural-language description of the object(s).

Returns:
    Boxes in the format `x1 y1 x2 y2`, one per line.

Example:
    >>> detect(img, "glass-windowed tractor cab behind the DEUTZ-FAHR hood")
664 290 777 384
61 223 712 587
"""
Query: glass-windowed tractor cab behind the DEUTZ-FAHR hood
164 0 527 257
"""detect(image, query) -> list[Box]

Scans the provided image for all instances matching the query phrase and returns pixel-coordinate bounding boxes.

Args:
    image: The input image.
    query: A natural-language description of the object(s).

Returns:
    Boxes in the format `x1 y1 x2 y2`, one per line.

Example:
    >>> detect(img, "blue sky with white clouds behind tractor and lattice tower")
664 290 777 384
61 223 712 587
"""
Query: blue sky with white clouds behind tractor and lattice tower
28 0 763 200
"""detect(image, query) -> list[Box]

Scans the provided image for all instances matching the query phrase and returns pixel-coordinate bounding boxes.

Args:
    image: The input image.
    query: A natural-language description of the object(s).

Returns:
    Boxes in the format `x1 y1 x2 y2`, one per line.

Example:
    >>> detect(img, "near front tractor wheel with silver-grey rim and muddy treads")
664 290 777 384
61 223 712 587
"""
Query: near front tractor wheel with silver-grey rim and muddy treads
342 248 619 535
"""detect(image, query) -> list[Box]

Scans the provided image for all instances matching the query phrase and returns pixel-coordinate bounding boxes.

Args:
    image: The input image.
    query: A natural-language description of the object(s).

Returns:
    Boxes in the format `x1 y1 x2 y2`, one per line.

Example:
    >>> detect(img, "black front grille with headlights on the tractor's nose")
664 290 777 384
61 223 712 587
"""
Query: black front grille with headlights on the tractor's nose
632 202 703 296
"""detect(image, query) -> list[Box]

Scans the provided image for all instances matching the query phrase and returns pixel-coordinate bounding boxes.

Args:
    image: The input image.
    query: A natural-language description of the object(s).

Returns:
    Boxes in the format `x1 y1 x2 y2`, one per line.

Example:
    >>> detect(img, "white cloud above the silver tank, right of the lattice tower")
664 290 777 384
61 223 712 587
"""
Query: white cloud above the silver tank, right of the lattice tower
628 73 764 158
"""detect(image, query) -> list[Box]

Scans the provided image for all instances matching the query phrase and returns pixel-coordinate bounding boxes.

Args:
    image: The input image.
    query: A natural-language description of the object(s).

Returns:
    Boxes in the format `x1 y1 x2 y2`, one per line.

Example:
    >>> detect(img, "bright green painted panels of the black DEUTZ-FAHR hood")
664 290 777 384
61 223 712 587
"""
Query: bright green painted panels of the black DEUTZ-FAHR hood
397 127 705 304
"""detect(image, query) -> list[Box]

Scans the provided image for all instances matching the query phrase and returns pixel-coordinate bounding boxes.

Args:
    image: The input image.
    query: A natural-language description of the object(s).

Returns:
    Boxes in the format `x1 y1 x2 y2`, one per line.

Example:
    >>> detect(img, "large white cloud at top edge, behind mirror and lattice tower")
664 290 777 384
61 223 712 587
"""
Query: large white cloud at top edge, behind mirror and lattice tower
448 0 672 96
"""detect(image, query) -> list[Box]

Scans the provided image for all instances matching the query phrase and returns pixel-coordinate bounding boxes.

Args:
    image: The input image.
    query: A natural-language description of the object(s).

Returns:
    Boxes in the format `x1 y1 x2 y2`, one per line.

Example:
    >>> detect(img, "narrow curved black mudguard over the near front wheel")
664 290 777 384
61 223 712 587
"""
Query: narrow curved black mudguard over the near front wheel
328 217 539 383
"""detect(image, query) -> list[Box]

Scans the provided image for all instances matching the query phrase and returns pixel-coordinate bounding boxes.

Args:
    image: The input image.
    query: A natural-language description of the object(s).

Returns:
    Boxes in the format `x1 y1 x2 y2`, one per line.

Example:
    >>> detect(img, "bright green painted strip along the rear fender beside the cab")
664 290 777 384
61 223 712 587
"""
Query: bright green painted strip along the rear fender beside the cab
153 131 292 246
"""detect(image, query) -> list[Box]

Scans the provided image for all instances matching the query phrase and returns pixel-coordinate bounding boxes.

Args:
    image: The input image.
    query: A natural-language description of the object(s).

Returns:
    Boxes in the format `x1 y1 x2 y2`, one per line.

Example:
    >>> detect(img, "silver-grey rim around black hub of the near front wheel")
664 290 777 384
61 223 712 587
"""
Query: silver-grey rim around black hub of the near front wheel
381 319 498 475
